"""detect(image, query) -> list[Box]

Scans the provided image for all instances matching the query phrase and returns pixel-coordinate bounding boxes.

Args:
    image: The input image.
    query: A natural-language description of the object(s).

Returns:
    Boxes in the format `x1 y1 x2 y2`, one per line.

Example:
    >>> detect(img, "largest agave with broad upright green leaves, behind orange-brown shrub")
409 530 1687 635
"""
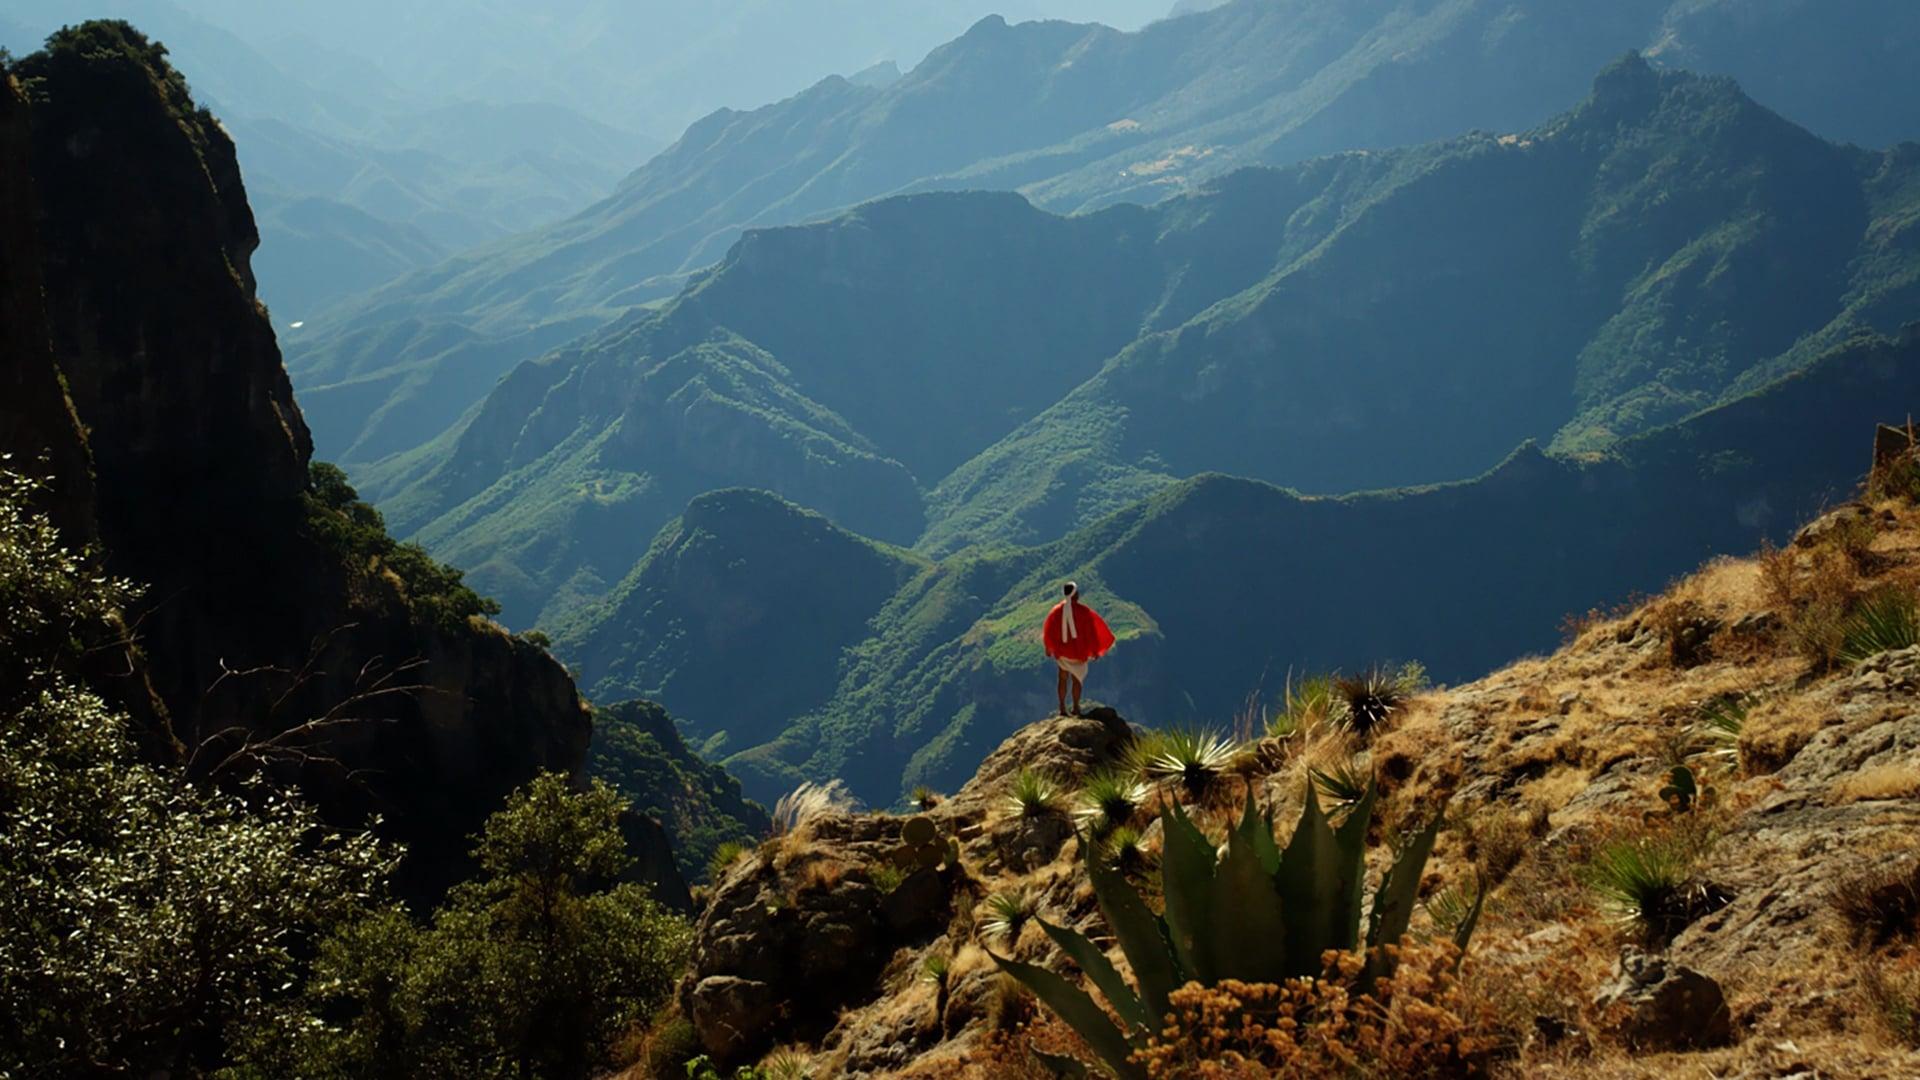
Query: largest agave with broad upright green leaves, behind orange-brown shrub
993 786 1478 1080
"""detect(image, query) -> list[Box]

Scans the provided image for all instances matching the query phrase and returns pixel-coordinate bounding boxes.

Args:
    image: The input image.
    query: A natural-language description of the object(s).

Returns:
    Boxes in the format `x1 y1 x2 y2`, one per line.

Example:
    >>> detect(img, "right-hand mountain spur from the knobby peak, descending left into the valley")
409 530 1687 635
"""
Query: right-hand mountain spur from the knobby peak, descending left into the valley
922 60 1920 553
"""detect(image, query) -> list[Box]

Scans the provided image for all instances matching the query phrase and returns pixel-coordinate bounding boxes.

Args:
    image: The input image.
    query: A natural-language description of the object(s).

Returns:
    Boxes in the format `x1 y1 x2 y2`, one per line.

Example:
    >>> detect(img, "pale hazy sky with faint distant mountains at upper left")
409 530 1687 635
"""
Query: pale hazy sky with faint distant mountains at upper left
0 0 1164 317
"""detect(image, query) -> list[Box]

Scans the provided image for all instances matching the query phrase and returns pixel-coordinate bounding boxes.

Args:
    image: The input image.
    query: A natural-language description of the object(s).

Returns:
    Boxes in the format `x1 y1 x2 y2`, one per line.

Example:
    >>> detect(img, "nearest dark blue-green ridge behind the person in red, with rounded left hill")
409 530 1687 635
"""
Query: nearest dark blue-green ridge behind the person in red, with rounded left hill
555 329 1920 805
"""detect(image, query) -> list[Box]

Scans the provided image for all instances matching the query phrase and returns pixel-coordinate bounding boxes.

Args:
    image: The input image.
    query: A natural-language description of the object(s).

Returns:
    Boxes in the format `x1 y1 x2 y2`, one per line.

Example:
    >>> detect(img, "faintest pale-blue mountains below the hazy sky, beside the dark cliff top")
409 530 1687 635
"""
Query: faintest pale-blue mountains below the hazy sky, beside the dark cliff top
0 0 659 317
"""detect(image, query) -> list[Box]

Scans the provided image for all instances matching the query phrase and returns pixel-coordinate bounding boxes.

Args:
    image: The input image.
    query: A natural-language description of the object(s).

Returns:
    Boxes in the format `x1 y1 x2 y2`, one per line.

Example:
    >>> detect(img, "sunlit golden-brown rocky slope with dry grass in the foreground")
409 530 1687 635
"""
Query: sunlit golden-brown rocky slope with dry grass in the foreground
652 432 1920 1080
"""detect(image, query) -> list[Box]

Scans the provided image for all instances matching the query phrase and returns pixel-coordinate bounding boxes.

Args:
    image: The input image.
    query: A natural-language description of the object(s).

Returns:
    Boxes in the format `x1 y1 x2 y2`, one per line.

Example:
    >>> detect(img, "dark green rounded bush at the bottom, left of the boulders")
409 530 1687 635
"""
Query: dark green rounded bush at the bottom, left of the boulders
240 773 691 1078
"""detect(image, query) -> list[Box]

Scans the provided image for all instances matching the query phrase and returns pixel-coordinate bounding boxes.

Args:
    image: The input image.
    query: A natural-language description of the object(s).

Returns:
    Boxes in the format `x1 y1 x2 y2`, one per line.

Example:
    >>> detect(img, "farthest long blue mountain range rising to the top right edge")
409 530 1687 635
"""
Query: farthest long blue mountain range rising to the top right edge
288 0 1920 465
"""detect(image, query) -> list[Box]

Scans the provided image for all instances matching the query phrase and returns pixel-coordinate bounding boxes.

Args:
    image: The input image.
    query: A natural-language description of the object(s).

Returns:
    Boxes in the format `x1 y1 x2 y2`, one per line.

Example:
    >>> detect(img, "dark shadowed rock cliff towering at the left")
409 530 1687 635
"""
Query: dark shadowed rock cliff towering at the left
0 23 672 894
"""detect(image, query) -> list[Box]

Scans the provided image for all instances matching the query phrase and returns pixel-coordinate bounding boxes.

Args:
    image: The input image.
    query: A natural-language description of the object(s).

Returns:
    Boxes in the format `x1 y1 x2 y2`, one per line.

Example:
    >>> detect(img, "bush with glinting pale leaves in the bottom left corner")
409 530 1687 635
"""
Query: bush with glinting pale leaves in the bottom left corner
0 471 390 1076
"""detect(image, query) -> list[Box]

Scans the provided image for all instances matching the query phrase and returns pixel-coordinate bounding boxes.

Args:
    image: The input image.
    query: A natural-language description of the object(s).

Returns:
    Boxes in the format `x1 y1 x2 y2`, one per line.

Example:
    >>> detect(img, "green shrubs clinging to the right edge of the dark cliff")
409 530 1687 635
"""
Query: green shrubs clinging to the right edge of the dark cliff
305 461 499 628
